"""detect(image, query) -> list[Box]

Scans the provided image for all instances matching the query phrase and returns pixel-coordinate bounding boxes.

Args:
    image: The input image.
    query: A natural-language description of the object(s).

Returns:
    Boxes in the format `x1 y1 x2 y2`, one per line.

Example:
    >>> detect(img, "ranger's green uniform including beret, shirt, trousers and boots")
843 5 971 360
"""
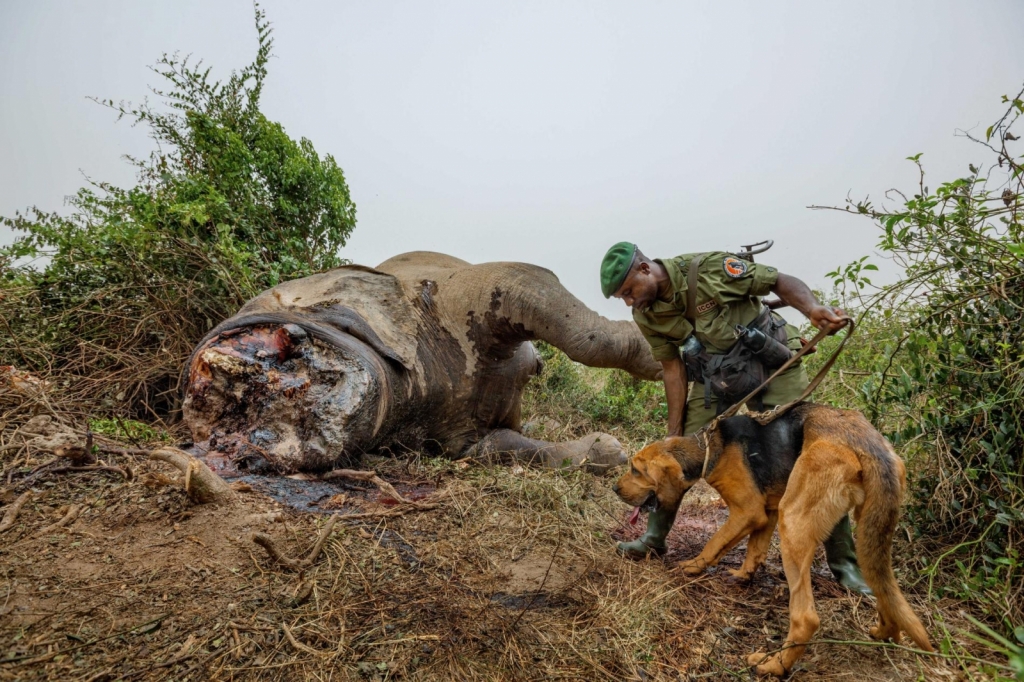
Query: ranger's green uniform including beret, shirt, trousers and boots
601 242 870 594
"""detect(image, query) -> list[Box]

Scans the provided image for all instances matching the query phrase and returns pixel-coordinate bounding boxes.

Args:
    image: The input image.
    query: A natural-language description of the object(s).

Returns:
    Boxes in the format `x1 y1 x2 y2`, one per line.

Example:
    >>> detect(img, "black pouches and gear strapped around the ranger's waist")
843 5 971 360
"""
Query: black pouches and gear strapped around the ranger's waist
681 306 793 415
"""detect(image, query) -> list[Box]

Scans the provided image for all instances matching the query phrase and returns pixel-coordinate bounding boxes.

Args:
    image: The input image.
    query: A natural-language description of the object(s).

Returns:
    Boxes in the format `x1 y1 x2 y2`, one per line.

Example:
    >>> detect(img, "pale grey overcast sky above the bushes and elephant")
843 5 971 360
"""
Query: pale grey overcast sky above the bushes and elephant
0 0 1024 318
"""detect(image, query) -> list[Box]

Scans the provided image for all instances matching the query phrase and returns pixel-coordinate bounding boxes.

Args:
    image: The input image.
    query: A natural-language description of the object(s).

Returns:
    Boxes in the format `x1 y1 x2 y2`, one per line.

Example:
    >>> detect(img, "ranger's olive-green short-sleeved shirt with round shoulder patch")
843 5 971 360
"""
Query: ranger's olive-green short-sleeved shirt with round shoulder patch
633 251 778 360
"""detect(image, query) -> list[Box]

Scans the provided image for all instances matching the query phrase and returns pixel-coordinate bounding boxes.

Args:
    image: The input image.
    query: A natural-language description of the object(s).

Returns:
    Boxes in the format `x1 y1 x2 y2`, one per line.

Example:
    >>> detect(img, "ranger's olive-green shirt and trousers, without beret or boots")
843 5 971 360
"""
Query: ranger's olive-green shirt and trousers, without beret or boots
633 251 808 434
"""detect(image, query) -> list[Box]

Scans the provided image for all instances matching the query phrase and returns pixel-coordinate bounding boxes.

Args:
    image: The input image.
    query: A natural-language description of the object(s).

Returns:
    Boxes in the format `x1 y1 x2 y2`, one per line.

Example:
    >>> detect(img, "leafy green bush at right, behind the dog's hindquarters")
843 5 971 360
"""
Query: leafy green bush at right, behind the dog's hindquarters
831 89 1024 632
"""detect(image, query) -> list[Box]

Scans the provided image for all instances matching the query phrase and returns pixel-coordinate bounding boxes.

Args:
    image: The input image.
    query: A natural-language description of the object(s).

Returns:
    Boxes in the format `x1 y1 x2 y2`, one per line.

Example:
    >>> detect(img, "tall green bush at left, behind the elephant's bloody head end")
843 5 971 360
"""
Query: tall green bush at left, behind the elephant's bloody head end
0 7 355 418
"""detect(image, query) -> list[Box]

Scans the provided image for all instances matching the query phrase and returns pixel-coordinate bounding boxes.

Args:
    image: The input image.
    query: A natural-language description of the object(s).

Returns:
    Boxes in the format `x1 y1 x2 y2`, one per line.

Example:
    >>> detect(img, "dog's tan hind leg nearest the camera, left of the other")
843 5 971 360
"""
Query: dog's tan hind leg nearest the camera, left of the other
746 441 858 677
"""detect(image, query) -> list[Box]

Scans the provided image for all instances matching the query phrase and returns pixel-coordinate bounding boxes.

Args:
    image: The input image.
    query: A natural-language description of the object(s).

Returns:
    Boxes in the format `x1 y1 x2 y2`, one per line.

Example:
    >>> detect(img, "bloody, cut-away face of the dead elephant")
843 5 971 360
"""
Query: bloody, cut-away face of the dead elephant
183 325 388 473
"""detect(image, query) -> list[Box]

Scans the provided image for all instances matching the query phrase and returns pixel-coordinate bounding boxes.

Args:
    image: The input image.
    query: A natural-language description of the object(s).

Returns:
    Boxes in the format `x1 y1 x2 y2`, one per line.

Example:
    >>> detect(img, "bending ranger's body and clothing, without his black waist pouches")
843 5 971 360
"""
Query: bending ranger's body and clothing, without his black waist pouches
601 242 870 594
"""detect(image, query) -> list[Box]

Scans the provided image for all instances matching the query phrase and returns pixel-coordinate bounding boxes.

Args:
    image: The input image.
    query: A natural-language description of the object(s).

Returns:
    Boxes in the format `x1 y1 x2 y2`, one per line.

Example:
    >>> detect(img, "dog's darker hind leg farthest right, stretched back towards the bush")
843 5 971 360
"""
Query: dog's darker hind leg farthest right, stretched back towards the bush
856 417 935 651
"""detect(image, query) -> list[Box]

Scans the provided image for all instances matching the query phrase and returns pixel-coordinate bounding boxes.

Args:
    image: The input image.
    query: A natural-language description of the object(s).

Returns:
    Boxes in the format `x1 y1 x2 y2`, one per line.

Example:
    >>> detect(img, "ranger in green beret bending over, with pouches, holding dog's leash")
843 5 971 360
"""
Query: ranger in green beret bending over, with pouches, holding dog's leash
601 242 870 594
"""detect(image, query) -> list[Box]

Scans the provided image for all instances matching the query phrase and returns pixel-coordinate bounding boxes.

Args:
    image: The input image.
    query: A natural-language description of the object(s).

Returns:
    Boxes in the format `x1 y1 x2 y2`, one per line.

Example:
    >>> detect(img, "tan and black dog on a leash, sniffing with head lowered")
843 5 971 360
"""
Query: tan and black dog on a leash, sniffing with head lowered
612 402 934 677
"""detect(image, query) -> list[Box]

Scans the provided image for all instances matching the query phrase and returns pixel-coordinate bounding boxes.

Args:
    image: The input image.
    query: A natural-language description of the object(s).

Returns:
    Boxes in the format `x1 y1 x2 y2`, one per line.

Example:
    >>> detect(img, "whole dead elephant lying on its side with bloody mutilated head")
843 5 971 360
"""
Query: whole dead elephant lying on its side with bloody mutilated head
183 252 660 472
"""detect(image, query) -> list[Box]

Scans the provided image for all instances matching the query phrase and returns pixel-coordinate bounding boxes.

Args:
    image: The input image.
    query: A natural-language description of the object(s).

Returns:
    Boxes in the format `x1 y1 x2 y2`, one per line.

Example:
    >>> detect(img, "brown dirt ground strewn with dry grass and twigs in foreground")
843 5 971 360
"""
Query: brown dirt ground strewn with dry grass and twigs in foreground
0 438 983 682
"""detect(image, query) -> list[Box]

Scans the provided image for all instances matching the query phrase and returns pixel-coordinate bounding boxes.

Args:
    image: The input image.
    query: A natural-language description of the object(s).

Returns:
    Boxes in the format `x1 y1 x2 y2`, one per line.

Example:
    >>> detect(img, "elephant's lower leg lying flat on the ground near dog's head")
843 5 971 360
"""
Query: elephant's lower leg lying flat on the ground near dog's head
466 429 627 473
